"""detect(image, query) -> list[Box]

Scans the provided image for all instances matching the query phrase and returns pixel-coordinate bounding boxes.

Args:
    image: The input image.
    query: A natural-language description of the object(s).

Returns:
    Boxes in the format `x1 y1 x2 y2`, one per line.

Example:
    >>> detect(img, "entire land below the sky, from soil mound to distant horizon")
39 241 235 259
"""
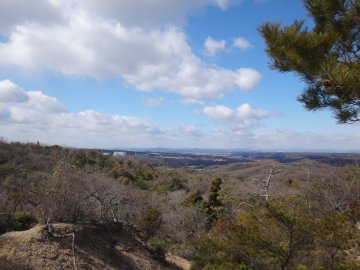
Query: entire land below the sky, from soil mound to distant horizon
0 141 360 270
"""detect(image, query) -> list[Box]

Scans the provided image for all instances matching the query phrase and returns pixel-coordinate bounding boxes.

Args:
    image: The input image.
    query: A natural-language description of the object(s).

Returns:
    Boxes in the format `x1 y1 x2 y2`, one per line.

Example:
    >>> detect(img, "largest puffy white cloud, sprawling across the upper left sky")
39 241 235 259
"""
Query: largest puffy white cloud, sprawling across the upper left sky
0 0 261 101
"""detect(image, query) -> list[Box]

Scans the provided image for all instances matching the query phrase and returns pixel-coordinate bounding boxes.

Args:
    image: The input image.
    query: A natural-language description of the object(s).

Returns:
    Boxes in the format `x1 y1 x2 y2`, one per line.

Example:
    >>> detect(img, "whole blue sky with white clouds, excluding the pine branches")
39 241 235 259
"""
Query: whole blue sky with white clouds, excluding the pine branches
0 0 360 151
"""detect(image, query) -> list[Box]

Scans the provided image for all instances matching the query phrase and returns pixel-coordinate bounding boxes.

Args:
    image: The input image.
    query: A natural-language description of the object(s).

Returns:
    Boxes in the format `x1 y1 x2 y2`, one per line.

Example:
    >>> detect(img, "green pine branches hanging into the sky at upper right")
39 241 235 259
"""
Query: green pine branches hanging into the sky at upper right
259 0 360 123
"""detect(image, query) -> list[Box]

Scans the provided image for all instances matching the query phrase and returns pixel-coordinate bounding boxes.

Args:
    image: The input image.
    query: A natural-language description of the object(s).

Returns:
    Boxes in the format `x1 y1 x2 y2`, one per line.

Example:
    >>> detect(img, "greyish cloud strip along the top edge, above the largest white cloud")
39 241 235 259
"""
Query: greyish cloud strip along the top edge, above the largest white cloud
0 0 241 33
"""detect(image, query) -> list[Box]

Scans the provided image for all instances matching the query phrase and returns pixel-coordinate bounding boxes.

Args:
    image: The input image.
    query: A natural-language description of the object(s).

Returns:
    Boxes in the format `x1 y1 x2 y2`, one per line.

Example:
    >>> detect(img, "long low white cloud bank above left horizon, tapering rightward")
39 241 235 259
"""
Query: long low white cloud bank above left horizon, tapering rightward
0 81 205 147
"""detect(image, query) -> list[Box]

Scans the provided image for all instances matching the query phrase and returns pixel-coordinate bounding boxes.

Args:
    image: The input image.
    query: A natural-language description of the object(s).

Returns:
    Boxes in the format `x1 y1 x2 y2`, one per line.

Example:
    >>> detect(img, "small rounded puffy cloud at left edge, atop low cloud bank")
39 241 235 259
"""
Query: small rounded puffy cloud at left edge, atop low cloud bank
0 80 29 103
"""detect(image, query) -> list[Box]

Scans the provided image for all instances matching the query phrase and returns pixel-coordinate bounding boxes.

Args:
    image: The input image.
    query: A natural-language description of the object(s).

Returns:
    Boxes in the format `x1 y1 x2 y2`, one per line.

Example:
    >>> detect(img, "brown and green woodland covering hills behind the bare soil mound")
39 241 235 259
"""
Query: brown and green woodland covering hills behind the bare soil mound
0 141 360 269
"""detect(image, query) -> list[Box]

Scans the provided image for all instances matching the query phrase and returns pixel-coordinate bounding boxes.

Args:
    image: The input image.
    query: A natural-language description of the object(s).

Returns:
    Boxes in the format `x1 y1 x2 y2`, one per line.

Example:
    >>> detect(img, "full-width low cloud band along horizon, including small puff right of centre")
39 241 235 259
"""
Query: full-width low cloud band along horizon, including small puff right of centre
0 81 360 150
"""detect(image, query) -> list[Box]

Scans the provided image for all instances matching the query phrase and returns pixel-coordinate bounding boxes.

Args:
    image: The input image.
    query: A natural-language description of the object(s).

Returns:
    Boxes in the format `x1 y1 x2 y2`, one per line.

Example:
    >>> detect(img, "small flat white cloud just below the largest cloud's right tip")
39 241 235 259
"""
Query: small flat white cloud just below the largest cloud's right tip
202 103 275 131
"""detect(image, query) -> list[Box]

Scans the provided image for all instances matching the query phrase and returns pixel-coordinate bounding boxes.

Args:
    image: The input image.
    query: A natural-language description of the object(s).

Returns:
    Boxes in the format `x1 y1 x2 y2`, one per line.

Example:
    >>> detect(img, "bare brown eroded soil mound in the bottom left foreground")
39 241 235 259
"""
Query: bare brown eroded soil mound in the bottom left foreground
0 224 179 270
